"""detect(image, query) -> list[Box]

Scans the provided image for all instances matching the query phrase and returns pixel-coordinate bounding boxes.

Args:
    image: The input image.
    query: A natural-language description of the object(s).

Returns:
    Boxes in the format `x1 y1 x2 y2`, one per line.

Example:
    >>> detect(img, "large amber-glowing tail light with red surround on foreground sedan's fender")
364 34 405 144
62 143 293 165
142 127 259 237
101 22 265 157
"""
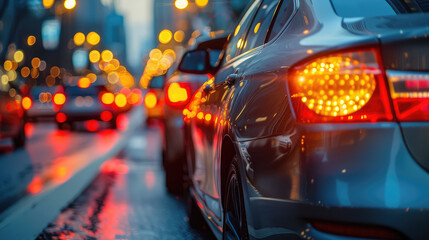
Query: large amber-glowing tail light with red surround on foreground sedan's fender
289 49 393 123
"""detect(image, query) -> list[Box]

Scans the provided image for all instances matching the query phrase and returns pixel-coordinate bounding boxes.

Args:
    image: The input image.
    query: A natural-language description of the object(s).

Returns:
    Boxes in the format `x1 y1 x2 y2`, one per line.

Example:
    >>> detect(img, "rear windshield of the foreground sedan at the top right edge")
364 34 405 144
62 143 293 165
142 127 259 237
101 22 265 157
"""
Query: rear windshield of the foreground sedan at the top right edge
331 0 429 18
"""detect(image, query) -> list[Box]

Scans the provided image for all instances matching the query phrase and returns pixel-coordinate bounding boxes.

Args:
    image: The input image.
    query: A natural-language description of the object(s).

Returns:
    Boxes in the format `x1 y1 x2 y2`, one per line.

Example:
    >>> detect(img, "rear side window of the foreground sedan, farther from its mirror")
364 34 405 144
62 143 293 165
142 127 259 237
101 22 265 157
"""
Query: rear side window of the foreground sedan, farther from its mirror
243 0 280 52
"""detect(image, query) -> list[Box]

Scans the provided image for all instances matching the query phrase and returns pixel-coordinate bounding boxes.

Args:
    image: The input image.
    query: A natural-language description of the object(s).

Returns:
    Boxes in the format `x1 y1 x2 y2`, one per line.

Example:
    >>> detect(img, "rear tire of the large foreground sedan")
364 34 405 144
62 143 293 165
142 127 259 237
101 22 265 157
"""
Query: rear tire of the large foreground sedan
222 157 249 240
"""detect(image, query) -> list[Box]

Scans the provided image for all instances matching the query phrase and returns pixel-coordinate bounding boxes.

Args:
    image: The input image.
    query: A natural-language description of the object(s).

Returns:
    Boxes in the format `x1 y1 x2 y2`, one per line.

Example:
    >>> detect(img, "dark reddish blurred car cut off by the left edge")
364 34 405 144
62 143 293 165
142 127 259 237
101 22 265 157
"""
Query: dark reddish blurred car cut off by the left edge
0 84 25 149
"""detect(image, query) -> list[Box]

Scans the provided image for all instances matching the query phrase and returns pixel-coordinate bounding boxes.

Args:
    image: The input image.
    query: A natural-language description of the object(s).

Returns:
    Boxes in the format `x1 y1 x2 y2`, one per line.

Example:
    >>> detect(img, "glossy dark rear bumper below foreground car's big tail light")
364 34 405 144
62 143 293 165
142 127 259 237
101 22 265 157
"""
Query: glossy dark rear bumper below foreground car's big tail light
238 123 429 239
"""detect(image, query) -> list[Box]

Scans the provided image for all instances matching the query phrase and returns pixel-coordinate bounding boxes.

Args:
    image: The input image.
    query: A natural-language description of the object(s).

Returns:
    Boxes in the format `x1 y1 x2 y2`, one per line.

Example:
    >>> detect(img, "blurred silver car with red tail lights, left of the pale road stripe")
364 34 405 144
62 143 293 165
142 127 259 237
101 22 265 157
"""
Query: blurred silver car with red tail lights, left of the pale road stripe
53 77 123 129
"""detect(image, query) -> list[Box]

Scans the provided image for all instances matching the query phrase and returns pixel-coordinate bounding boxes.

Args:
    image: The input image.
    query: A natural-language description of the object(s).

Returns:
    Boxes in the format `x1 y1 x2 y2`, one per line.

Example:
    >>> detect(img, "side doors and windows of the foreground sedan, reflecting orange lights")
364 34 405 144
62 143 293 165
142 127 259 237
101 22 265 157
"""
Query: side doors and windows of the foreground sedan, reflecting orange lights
192 0 279 225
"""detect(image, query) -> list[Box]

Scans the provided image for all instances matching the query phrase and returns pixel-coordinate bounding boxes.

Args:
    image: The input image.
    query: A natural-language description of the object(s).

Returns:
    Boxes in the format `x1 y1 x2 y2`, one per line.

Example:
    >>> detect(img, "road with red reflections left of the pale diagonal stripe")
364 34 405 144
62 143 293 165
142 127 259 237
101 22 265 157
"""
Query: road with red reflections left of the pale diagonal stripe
0 122 121 212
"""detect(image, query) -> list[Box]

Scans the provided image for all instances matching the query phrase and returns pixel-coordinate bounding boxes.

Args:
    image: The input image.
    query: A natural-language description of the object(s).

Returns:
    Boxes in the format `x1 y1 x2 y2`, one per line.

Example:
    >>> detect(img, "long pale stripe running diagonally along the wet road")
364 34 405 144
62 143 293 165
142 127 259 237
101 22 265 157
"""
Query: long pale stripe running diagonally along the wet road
0 107 143 240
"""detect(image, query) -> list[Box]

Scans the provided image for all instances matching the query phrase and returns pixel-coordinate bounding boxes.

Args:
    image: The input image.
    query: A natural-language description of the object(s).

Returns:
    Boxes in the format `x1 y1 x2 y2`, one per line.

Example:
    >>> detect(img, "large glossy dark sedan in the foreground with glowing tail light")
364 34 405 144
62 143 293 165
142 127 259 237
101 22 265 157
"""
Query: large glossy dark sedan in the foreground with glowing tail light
179 0 429 239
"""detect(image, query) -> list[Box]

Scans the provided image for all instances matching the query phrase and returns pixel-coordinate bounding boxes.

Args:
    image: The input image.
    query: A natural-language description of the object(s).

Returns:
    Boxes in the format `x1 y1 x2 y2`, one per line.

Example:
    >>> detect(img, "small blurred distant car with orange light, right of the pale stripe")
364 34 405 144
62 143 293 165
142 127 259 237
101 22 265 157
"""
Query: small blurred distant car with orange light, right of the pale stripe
144 75 165 121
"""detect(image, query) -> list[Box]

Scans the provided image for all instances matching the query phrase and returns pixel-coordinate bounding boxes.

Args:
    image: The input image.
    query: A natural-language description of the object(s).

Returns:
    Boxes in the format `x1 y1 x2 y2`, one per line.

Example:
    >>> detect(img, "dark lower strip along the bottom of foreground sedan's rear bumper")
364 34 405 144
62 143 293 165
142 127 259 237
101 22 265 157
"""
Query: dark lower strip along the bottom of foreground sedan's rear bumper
249 198 429 240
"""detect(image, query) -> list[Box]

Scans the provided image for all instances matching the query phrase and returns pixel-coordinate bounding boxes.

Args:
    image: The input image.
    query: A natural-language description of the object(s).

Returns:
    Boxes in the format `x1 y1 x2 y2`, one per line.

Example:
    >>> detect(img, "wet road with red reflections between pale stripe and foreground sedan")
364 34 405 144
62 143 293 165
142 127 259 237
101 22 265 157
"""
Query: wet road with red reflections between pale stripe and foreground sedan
37 124 213 239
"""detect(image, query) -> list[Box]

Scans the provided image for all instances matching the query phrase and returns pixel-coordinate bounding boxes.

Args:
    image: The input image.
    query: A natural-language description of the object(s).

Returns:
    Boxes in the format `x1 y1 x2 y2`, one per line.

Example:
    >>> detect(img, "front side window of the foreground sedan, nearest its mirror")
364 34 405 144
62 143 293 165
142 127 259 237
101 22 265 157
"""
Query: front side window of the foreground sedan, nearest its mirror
224 0 261 62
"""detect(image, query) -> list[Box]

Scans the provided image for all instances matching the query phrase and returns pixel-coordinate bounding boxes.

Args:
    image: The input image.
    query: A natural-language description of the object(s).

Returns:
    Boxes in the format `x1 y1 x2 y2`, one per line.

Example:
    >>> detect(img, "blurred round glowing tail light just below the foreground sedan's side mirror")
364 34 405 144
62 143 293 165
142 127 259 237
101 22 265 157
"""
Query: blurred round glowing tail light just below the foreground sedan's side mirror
165 83 191 107
